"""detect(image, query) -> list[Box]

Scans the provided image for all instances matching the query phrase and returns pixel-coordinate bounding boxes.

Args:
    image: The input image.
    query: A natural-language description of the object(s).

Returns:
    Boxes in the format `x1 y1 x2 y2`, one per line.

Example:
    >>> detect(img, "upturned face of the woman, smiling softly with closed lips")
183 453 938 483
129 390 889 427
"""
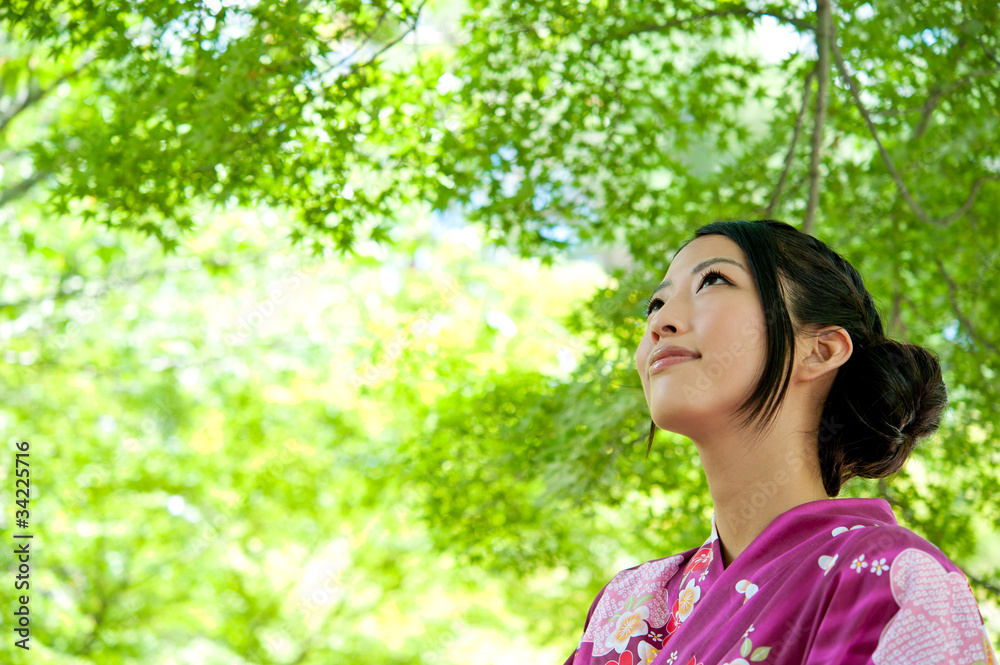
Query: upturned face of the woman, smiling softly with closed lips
635 235 766 441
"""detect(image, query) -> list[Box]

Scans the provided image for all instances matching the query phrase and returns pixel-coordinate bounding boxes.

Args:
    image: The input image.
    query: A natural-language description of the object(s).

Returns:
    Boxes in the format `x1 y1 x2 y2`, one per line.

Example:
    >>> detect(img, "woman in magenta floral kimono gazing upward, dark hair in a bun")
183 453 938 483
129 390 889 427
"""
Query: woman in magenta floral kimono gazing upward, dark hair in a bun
566 220 997 665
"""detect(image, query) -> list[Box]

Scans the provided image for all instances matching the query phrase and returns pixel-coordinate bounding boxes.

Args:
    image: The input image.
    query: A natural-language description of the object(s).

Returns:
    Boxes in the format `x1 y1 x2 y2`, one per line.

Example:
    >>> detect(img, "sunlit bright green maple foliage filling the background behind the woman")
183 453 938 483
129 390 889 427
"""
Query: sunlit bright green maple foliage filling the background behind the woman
0 0 1000 663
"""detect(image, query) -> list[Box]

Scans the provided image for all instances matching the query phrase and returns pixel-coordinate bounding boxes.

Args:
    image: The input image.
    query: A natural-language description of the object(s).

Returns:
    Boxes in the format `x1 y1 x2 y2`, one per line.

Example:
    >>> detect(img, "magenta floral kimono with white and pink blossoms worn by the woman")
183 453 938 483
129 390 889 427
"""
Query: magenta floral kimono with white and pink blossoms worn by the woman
566 499 997 665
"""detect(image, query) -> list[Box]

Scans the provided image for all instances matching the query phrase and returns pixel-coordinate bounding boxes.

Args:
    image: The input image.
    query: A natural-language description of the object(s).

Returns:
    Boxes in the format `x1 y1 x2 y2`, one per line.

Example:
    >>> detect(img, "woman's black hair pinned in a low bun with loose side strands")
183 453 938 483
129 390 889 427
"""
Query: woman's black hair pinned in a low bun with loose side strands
647 219 948 496
